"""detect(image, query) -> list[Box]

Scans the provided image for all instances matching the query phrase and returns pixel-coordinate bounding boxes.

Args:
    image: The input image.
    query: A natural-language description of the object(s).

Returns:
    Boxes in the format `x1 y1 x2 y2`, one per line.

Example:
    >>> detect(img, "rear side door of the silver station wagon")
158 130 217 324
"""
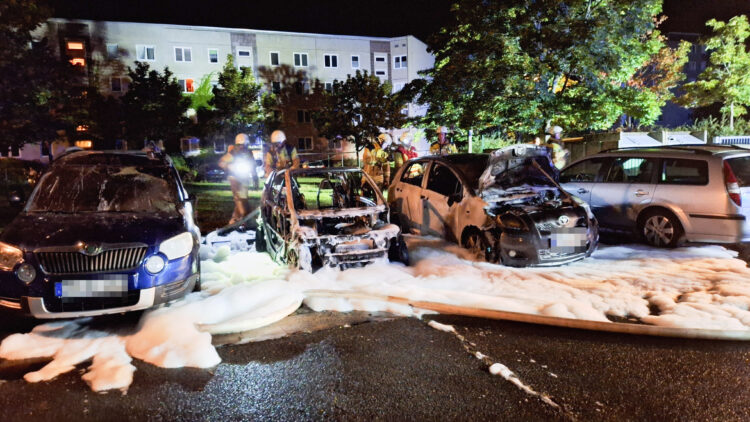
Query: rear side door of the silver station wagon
589 157 659 229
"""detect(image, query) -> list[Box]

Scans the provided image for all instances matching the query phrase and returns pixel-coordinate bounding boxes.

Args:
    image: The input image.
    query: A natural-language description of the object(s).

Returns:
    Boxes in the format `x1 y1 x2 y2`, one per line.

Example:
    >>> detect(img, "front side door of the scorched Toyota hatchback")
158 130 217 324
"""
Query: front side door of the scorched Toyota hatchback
420 161 464 238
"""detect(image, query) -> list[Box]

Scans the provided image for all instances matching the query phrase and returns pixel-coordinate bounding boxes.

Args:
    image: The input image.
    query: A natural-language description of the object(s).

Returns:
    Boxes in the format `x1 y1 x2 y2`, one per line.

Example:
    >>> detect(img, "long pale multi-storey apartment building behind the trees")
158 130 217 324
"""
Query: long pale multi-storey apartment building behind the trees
39 19 434 157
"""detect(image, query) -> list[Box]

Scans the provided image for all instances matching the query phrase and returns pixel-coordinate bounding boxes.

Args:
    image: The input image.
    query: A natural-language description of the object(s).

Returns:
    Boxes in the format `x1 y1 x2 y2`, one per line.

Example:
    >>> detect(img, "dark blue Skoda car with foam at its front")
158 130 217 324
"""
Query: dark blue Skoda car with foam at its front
0 151 200 318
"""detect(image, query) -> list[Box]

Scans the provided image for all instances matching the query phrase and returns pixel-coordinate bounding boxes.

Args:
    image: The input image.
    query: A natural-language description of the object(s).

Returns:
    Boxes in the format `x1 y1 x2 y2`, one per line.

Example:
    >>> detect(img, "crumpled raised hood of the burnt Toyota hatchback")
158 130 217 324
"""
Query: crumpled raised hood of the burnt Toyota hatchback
480 145 560 190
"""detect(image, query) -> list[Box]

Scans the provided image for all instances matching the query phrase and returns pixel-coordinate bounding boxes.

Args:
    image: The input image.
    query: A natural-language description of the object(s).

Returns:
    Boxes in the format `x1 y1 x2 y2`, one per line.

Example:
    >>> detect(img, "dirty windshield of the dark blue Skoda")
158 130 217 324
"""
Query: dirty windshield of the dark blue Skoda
26 165 177 213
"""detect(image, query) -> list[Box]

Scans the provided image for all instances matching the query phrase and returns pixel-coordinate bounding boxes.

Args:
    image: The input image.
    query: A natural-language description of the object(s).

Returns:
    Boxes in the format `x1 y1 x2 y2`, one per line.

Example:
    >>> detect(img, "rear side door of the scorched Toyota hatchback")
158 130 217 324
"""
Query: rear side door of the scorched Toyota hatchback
391 160 429 232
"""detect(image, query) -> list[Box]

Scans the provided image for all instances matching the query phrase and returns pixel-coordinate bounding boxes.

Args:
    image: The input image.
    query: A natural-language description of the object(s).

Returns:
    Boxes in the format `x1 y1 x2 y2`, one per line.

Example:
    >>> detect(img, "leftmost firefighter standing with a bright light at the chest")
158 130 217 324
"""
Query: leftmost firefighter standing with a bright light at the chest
219 133 258 224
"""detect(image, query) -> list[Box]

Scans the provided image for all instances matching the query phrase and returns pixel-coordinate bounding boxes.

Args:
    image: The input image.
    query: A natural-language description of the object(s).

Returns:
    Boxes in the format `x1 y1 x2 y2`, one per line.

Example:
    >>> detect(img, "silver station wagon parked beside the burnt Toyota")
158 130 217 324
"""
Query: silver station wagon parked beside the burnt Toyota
560 145 750 247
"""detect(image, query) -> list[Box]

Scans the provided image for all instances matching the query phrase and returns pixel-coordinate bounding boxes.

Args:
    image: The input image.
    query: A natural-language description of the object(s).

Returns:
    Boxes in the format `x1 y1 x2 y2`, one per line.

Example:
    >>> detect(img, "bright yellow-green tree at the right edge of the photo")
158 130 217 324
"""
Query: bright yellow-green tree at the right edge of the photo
681 15 750 130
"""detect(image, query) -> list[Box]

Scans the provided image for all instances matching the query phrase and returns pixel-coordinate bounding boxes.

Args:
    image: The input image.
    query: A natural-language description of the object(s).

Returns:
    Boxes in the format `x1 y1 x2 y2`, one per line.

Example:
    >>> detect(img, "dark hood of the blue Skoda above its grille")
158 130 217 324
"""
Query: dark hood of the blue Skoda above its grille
0 213 187 250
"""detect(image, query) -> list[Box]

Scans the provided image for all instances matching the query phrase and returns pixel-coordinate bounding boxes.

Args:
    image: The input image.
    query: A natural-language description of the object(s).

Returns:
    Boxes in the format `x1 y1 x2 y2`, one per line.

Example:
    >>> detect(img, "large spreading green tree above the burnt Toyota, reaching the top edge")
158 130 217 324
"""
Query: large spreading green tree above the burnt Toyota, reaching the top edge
407 0 663 137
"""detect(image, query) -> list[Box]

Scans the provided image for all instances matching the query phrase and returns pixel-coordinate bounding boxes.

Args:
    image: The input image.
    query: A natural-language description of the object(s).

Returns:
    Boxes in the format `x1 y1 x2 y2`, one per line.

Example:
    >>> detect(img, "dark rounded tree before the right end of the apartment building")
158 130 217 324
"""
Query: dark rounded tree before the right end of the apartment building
314 70 406 160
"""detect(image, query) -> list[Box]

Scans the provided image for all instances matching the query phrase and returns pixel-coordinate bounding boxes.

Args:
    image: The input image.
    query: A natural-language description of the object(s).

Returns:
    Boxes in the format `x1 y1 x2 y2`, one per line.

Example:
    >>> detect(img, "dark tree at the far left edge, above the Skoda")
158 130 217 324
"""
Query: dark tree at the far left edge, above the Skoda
0 0 75 153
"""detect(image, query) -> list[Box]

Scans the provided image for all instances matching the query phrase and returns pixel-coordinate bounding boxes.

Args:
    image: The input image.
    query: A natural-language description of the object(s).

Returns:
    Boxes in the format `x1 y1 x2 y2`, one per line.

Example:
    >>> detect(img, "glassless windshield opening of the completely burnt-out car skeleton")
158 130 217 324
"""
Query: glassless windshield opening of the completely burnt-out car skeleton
290 169 379 211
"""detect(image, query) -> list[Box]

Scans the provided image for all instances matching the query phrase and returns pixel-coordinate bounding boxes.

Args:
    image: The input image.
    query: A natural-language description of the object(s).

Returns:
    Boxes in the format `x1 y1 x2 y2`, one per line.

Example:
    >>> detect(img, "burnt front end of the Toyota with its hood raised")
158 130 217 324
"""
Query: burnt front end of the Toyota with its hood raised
479 145 599 266
